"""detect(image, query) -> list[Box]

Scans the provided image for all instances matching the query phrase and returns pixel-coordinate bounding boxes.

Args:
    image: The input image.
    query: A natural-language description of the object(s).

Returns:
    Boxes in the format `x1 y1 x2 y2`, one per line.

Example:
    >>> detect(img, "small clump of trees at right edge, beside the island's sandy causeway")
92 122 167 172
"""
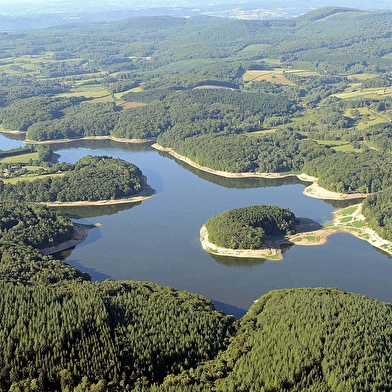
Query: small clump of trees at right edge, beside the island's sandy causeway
362 187 392 241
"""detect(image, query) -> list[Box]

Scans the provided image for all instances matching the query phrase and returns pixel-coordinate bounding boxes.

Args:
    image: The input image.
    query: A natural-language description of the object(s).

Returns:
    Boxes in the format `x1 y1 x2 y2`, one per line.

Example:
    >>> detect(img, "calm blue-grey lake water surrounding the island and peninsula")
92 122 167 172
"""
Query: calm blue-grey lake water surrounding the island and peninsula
0 135 392 315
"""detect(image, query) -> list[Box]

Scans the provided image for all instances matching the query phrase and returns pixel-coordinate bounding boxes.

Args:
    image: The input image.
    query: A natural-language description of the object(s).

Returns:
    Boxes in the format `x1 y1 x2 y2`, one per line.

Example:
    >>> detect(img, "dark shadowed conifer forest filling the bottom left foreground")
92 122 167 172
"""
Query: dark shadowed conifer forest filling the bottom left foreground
0 281 233 390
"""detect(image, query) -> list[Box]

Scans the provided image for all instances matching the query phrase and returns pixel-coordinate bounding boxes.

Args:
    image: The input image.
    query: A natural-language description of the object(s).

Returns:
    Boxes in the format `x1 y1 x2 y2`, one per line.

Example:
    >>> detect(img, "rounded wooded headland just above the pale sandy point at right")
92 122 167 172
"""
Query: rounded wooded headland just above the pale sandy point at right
303 151 392 193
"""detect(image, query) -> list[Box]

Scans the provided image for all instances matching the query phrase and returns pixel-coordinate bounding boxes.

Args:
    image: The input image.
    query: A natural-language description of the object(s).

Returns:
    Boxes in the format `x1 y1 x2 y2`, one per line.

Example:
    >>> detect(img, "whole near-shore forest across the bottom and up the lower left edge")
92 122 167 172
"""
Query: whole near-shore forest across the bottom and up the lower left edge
0 203 392 392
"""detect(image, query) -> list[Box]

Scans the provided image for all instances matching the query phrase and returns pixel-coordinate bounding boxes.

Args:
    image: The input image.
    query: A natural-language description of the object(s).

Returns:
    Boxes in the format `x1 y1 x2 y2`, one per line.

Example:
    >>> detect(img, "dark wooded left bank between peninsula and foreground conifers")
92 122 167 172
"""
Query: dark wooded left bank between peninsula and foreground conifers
0 201 90 284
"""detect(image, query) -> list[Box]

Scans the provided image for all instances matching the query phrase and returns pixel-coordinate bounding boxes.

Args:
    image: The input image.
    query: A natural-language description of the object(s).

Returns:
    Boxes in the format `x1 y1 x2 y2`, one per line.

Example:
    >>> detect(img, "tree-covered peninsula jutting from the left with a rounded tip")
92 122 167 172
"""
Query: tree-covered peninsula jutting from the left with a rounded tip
0 156 145 202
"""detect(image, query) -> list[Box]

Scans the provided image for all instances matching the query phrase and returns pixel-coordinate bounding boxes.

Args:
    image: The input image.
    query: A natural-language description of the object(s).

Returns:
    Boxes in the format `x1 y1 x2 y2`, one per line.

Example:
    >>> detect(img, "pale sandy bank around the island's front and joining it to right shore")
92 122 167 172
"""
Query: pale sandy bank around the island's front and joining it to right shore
200 203 392 260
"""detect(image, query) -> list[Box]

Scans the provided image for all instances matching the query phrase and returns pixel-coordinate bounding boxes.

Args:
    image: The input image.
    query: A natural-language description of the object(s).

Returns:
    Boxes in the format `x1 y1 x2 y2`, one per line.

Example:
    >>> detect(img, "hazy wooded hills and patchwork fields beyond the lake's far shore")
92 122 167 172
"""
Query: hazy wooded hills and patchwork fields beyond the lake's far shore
0 7 392 201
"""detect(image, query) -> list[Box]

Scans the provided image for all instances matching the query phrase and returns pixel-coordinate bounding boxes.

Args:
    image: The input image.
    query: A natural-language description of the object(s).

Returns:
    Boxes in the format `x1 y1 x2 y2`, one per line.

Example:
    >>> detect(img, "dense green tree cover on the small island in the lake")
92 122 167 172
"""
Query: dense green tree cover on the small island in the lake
205 204 297 249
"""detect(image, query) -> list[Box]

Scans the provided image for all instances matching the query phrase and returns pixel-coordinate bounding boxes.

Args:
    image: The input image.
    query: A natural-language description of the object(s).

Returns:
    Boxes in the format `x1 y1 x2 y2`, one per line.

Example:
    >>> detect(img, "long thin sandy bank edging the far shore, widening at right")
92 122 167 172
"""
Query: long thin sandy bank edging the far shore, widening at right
151 143 368 200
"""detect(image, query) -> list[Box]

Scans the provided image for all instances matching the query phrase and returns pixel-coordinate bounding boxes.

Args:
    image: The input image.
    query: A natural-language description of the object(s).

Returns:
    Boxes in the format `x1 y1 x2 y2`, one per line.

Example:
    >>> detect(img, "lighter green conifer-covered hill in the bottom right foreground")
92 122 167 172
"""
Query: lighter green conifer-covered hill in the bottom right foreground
153 289 392 392
